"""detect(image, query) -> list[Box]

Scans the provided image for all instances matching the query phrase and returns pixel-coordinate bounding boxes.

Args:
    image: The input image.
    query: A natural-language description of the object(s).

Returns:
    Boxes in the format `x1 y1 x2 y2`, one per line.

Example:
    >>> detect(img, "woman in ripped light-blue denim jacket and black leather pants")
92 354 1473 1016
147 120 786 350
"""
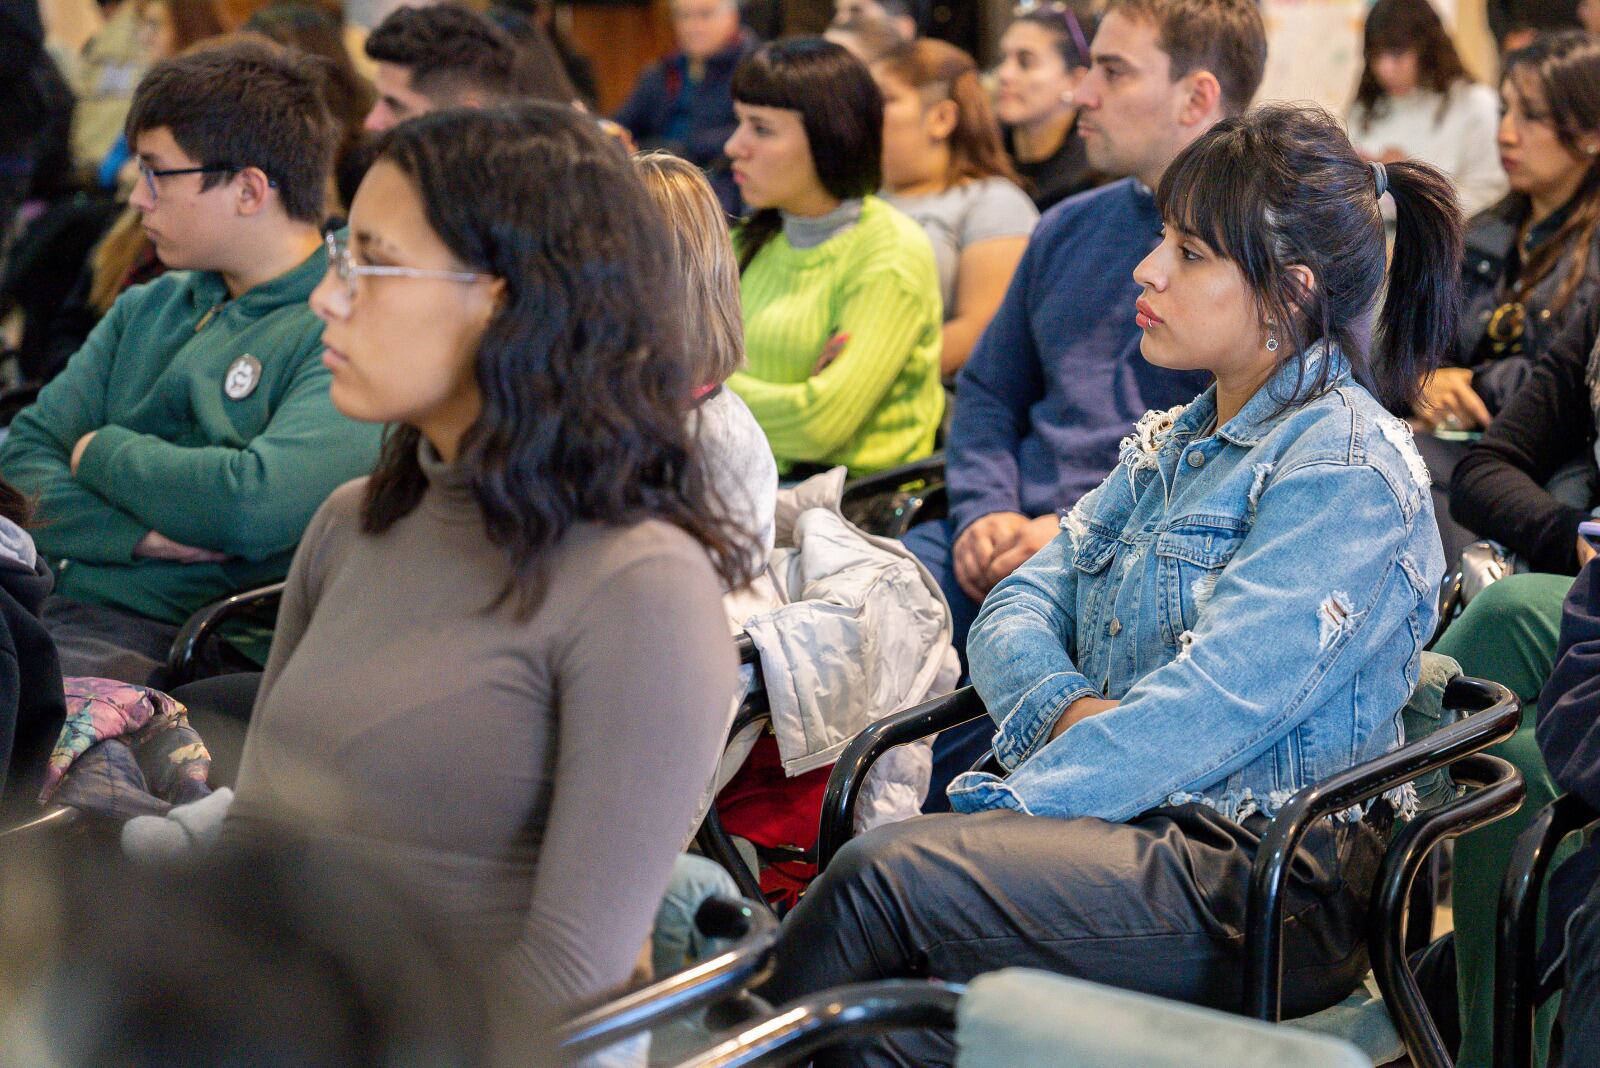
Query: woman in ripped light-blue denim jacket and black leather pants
763 106 1461 1065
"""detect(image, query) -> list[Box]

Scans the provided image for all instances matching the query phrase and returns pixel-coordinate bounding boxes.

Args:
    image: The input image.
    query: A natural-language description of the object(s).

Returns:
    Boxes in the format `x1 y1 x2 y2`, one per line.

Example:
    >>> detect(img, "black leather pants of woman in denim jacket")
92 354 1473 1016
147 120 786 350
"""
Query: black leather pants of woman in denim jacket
760 804 1382 1065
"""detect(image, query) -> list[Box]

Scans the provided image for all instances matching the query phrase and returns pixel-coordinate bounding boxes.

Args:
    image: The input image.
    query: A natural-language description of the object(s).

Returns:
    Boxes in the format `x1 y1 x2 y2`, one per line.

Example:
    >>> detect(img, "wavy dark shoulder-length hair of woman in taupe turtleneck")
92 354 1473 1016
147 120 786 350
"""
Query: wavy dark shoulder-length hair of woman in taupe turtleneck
362 102 750 616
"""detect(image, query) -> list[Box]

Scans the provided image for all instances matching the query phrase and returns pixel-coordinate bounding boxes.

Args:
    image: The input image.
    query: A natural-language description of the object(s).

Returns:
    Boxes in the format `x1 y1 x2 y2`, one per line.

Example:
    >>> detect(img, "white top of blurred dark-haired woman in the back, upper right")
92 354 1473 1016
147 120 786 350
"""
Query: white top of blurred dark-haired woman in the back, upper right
1349 82 1510 219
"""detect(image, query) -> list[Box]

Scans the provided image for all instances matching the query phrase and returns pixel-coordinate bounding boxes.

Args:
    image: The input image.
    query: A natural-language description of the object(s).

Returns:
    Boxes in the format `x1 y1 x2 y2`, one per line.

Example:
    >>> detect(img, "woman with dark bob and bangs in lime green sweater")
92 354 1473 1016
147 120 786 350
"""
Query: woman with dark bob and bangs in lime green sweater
726 38 944 478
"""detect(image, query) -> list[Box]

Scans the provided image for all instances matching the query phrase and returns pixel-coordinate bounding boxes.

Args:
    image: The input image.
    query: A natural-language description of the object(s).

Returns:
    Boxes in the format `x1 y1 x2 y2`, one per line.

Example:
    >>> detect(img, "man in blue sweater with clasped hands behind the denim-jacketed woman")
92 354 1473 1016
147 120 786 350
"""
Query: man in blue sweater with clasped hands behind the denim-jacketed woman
906 0 1267 806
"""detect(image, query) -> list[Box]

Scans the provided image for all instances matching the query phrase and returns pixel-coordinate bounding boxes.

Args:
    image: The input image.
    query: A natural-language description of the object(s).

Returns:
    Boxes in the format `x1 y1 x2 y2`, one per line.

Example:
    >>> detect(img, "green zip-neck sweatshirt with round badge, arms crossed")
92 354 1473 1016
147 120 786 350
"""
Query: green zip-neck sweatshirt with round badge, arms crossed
0 249 382 659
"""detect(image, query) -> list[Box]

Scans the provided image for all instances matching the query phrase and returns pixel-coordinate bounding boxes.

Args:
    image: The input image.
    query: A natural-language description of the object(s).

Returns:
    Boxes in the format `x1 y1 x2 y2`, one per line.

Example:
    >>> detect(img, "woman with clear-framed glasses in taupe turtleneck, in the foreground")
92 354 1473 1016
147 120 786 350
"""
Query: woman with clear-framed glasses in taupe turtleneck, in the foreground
224 104 750 1048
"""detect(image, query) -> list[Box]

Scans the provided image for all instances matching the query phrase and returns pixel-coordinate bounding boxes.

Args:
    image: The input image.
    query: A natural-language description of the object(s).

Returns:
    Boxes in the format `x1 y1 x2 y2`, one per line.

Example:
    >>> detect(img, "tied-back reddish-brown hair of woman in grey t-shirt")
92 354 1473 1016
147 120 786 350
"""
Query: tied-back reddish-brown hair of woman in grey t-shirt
878 37 1022 189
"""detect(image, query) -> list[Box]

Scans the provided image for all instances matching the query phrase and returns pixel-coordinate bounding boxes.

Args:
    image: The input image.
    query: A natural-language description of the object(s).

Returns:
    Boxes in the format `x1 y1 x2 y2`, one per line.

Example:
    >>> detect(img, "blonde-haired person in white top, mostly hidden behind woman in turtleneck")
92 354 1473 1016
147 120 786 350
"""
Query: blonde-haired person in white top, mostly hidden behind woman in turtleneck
634 152 778 572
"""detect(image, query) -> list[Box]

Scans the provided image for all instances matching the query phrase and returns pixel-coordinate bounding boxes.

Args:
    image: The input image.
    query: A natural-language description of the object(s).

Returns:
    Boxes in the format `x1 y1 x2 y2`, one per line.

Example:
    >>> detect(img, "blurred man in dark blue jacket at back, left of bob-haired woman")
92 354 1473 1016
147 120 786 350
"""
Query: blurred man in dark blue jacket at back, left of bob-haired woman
613 0 757 216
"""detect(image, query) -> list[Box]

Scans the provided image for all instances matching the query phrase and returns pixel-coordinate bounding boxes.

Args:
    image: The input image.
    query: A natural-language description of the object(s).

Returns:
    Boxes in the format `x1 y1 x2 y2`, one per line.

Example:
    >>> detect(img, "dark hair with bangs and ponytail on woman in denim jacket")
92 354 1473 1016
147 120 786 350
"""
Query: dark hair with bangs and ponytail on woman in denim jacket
1157 104 1462 411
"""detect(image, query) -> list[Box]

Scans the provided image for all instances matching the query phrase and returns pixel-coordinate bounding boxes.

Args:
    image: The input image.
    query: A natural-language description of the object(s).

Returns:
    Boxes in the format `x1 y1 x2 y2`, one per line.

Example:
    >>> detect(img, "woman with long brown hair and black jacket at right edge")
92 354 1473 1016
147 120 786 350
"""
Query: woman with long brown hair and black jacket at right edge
1416 30 1600 563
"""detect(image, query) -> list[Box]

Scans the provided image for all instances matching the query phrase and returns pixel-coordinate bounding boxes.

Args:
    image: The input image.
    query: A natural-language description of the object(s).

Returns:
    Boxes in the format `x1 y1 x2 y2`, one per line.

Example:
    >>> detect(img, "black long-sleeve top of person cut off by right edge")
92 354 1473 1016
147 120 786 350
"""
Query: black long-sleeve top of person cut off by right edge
1450 292 1600 574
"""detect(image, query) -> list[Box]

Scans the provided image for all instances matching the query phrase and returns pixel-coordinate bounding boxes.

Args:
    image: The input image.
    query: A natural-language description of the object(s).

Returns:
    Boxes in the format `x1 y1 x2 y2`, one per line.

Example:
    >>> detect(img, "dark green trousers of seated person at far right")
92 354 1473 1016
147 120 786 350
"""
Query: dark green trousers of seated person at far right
1434 574 1573 1068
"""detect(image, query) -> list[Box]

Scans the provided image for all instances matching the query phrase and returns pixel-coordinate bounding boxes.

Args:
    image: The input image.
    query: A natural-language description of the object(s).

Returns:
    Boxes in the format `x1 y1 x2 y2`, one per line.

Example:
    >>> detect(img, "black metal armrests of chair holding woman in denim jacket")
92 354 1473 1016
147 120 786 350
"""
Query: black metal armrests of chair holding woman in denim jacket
818 678 1523 1063
